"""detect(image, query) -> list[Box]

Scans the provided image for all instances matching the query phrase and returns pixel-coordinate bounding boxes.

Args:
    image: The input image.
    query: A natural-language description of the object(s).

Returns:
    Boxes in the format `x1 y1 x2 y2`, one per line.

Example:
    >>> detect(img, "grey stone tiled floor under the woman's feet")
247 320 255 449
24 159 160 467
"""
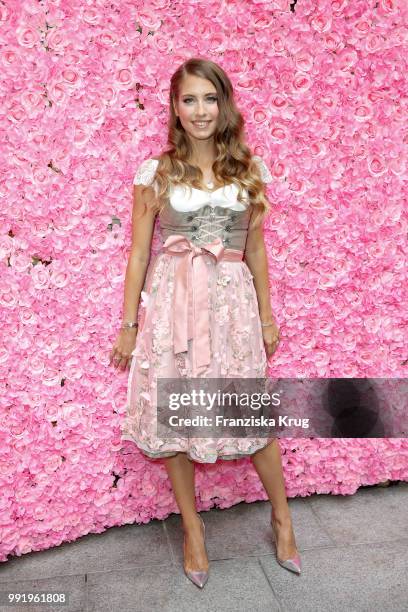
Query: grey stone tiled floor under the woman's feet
0 482 408 612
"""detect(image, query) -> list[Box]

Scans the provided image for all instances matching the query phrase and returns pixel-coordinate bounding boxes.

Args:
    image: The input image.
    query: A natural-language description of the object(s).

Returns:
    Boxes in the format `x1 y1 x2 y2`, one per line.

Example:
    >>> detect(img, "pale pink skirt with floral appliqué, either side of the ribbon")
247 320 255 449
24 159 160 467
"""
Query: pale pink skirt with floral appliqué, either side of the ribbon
121 252 272 463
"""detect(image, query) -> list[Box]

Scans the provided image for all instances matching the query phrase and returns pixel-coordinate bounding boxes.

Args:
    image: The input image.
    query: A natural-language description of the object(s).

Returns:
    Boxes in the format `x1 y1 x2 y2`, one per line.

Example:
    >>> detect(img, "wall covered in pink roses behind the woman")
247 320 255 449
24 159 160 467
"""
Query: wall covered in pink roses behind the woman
0 0 408 561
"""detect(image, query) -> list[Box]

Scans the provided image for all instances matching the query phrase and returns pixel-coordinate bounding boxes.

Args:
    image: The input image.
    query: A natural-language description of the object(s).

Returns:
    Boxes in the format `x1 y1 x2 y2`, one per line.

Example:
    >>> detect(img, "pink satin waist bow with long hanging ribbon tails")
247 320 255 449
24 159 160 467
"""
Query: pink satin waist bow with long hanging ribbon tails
163 234 243 377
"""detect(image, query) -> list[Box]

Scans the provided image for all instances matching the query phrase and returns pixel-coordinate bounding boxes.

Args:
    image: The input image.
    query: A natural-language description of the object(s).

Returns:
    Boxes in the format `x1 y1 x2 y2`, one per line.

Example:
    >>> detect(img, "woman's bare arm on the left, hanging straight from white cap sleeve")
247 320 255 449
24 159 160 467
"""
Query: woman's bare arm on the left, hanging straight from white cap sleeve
109 185 157 370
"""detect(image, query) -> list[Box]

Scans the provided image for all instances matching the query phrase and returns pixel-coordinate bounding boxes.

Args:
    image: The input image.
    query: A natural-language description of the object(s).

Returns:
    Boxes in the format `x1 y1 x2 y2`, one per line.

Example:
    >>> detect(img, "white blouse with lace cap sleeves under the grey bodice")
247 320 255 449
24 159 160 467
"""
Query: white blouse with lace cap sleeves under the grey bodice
133 155 272 212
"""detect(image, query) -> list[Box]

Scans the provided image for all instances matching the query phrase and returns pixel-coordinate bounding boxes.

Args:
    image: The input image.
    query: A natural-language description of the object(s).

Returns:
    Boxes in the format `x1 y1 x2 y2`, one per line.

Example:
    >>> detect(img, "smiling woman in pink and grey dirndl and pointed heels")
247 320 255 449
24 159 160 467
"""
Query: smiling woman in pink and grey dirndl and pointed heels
110 58 300 587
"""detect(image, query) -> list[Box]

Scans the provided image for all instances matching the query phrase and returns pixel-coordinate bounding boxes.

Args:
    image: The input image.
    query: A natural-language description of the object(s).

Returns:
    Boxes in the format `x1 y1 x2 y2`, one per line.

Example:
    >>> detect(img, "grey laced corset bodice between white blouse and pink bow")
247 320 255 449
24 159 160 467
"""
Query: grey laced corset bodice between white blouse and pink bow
159 203 250 251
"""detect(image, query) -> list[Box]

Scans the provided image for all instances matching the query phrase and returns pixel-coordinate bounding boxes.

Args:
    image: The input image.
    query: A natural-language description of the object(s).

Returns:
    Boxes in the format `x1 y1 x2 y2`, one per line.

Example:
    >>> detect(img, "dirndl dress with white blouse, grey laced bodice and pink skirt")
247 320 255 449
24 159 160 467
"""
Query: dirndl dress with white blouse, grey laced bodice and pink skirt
121 156 272 463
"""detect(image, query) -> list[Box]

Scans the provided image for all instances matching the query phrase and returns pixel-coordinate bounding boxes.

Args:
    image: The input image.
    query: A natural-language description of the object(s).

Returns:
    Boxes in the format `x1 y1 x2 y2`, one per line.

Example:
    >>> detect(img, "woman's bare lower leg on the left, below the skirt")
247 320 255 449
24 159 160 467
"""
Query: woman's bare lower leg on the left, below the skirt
164 453 208 571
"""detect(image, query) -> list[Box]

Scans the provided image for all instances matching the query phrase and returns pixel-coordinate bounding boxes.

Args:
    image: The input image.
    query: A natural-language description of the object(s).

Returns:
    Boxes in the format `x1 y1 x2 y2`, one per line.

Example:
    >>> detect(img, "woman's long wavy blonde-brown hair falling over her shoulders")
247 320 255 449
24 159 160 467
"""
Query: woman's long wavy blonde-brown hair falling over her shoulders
140 58 270 227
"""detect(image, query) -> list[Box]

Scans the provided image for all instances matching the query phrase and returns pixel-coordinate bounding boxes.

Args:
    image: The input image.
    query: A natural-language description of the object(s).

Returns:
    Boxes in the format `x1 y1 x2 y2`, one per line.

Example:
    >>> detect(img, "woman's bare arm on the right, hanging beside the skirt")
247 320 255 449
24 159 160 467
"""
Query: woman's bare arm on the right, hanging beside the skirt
244 222 279 356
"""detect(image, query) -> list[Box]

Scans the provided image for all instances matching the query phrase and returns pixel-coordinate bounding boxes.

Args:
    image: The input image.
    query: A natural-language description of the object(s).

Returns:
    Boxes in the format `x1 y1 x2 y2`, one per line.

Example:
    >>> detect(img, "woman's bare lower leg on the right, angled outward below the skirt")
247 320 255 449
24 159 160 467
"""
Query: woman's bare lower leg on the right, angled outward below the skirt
251 439 297 559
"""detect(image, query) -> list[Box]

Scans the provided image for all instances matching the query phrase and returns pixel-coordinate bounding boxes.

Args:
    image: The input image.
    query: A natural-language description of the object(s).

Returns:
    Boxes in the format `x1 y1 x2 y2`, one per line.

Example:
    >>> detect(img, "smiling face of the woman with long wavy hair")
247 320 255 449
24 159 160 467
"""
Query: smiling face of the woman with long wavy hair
174 74 219 140
